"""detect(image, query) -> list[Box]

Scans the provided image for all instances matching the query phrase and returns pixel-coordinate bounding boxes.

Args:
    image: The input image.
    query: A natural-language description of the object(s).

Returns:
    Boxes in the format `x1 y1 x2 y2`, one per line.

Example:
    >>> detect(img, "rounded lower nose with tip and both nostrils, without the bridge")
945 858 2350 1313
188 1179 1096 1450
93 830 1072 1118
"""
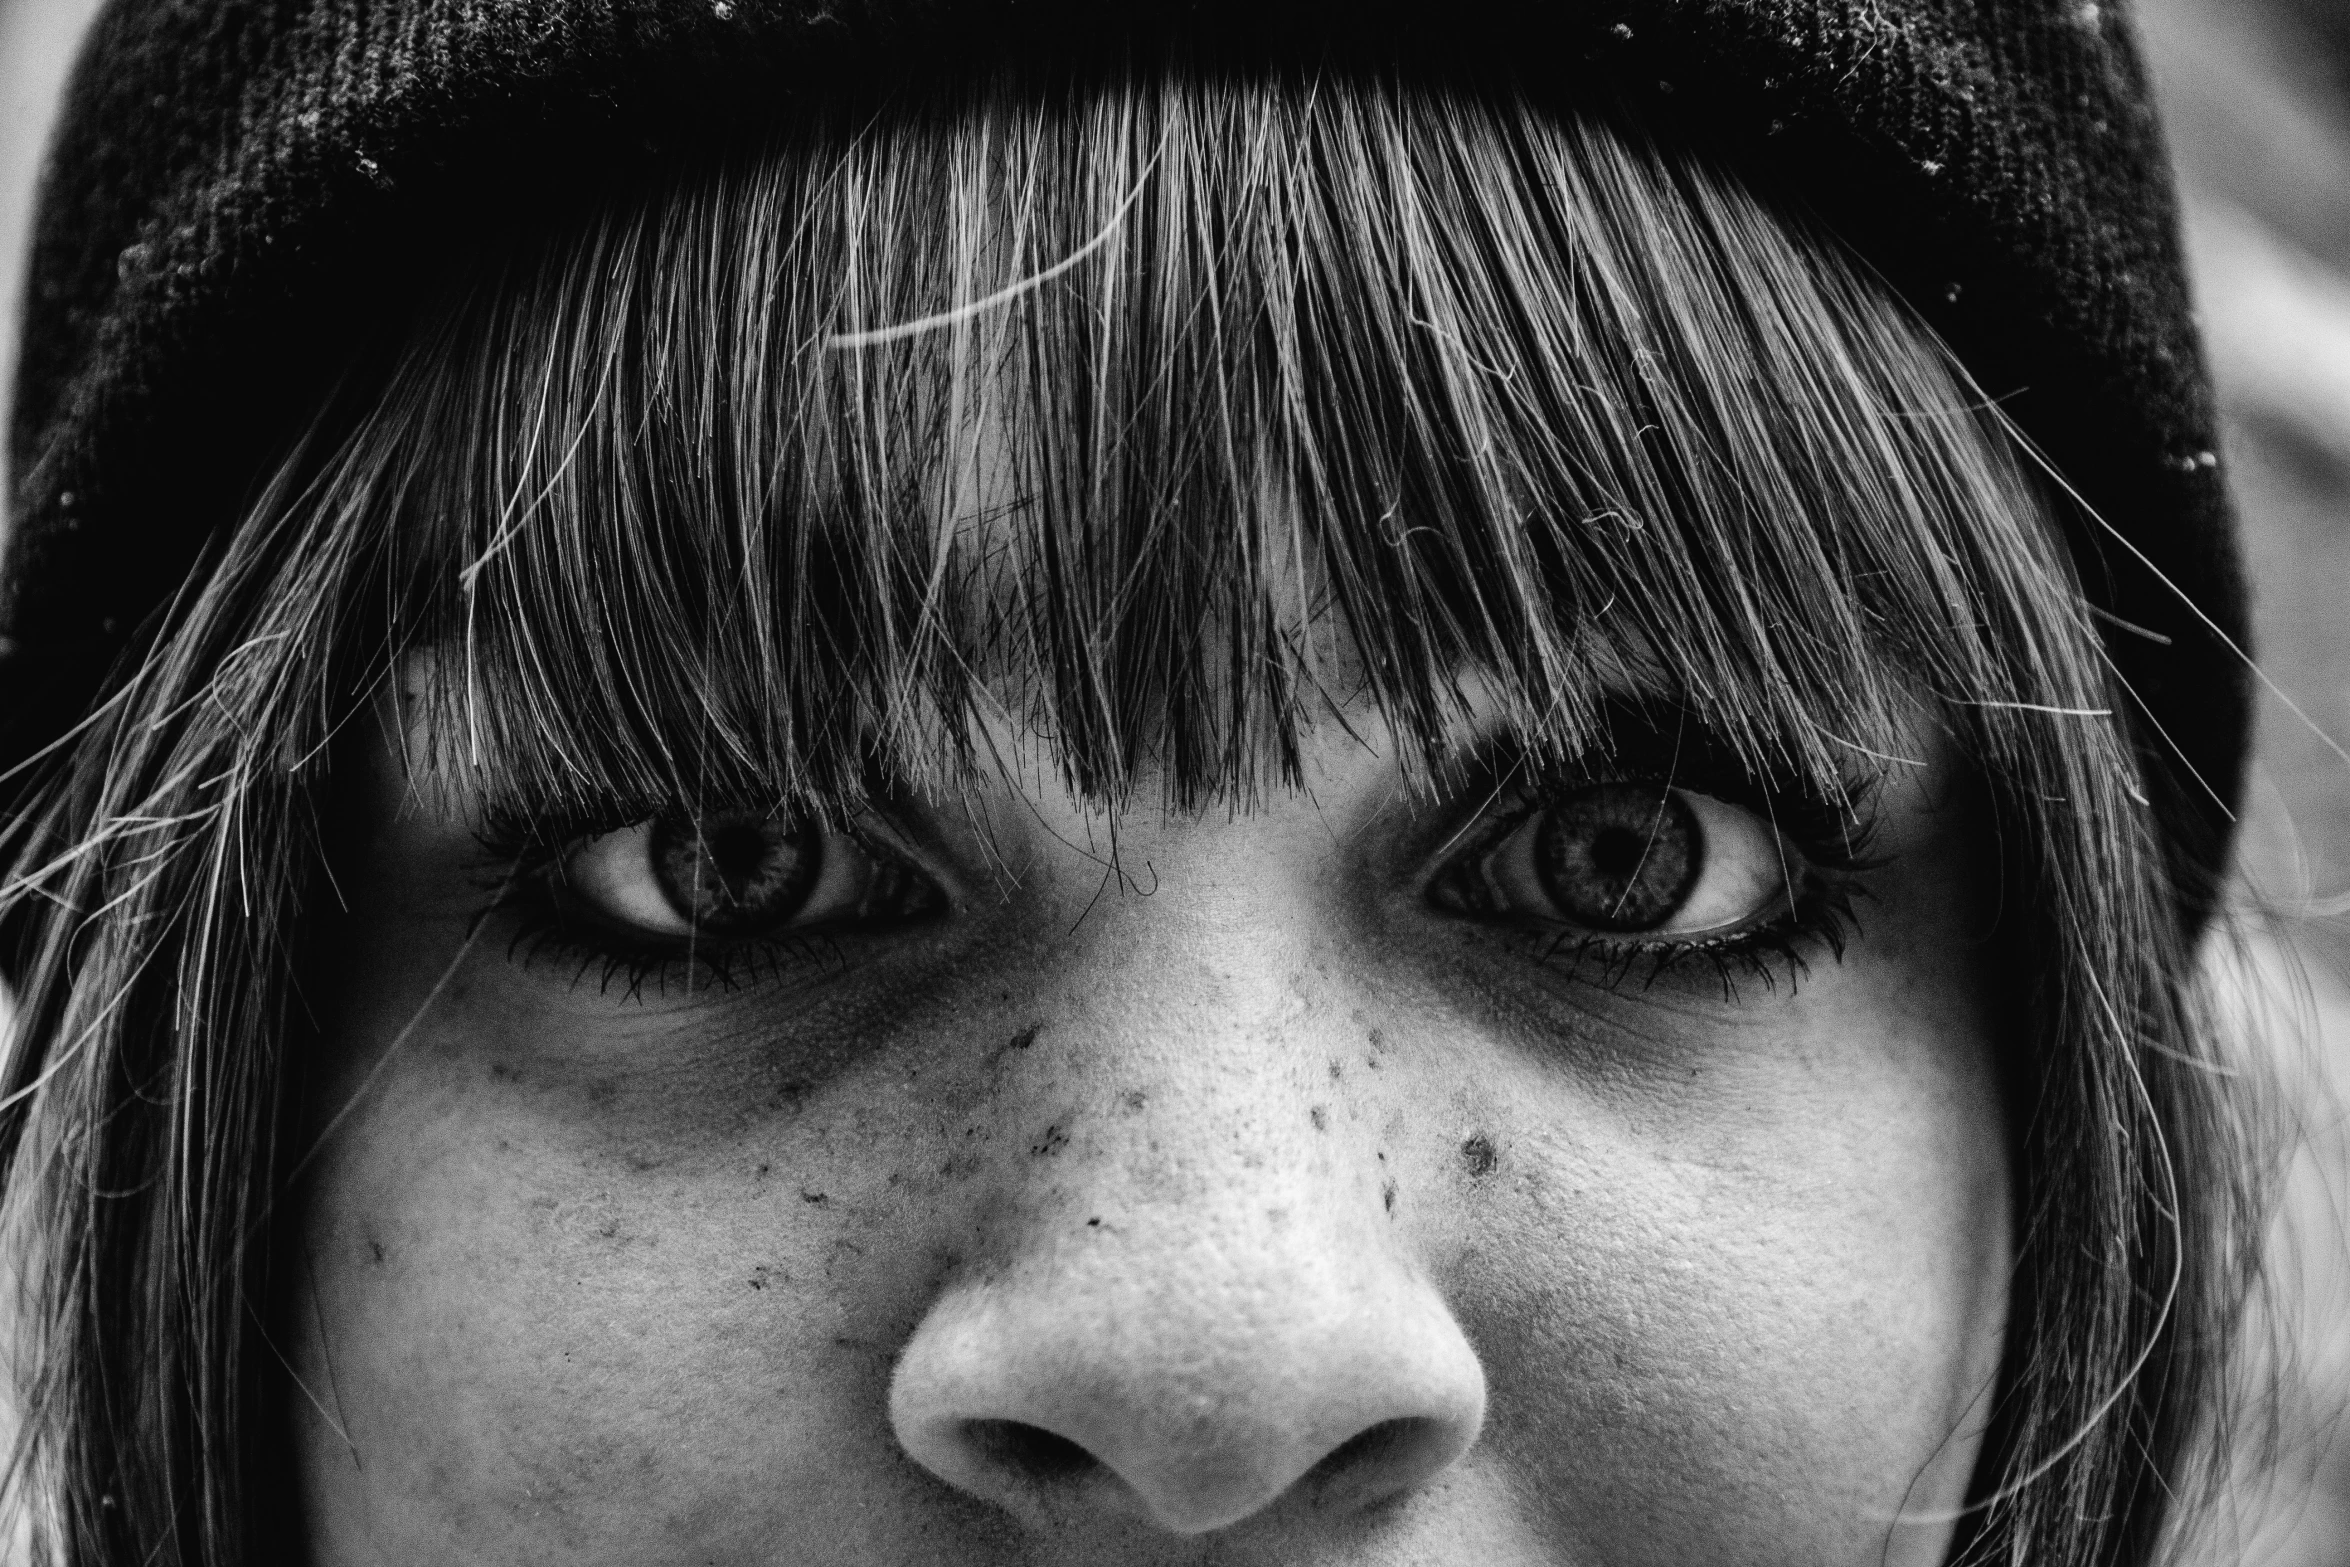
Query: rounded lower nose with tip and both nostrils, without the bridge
891 1224 1485 1534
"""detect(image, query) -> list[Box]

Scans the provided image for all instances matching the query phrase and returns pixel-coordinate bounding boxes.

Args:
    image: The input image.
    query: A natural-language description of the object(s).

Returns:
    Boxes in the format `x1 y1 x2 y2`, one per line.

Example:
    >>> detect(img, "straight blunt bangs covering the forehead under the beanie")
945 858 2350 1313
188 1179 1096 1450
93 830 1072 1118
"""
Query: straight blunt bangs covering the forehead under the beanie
352 75 2120 820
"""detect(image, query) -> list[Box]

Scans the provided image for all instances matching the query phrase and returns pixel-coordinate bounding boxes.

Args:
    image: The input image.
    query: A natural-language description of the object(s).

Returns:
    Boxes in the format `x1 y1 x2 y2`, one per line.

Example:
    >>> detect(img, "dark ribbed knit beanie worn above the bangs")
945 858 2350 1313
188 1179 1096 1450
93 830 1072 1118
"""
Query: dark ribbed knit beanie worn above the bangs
0 0 2247 928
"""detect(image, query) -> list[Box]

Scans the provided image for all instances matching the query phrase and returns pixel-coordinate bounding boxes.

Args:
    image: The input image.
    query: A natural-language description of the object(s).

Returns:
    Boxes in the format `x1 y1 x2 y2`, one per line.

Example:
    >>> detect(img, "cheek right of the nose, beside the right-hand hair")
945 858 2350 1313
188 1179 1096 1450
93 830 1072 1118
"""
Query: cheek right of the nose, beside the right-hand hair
1457 967 2009 1562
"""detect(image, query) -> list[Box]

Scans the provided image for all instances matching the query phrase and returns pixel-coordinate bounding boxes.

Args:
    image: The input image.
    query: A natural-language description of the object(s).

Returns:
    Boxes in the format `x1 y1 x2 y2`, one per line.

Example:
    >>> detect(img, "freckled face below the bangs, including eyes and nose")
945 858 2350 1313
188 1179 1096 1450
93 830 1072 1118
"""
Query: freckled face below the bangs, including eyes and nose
282 648 2009 1567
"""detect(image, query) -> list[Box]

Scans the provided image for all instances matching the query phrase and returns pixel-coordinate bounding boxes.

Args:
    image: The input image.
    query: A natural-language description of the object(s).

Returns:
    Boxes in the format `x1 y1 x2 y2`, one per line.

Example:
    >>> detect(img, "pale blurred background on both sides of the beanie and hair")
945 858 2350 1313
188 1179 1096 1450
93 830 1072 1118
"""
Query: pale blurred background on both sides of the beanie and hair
0 0 2350 1567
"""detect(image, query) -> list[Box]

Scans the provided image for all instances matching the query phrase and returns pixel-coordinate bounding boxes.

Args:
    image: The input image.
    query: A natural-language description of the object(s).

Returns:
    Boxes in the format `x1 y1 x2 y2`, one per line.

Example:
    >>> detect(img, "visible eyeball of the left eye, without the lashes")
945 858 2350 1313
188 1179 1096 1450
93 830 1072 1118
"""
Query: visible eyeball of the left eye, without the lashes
562 813 942 940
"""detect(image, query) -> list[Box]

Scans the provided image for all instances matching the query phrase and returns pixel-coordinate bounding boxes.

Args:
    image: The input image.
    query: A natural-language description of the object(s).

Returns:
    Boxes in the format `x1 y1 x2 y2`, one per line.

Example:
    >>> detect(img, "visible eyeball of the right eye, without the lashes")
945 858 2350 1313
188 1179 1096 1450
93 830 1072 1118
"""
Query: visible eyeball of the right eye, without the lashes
1434 782 1802 940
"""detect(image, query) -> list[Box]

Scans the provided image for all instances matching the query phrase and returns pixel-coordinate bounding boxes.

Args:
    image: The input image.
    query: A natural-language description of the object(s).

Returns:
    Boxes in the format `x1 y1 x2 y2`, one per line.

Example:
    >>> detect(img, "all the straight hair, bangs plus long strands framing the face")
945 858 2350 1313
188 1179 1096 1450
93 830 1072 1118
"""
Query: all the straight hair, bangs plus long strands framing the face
0 66 2254 1567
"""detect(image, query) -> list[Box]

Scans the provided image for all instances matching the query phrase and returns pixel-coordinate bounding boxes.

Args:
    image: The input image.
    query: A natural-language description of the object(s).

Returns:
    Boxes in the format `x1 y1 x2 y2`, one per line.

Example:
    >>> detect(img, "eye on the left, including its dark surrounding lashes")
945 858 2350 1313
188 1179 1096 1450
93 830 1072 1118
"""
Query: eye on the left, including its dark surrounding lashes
481 811 947 996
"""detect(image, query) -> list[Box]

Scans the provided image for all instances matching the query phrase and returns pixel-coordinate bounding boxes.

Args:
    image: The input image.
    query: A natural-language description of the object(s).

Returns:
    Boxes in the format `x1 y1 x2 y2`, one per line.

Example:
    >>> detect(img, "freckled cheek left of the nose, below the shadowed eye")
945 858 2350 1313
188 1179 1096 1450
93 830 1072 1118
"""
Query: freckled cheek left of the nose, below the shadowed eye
287 1010 994 1567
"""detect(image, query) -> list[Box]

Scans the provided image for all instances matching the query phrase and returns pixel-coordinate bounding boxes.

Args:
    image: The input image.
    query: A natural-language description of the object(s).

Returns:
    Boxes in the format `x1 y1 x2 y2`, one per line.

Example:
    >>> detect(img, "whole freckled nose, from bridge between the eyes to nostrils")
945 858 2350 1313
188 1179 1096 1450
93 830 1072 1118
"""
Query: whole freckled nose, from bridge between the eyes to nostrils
891 888 1483 1532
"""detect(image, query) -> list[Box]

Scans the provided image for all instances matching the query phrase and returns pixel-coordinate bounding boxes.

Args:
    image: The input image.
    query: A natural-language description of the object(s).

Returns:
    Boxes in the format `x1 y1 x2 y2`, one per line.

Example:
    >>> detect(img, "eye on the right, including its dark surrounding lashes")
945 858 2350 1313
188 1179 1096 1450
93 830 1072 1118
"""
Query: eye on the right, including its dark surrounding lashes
1429 742 1868 987
